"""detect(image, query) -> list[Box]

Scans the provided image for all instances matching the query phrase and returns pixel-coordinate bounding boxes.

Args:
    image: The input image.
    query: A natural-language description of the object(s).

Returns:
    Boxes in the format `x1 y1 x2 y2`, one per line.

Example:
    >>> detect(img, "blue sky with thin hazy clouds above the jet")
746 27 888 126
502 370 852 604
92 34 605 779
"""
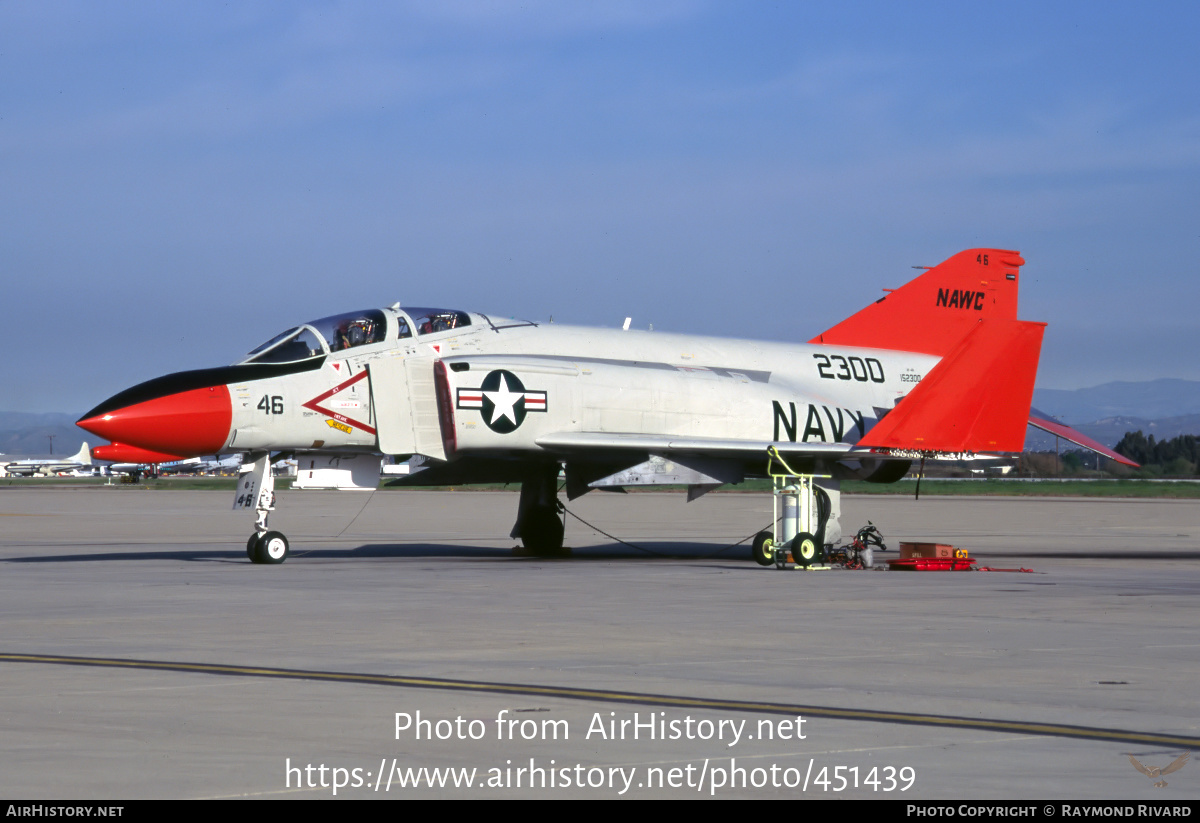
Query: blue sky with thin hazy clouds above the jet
0 0 1200 413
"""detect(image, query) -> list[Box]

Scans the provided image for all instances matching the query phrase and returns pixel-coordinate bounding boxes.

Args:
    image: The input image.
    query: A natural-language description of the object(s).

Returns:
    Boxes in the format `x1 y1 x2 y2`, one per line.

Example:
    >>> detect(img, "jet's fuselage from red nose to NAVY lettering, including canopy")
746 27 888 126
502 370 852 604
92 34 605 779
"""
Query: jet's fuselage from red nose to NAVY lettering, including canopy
79 306 938 459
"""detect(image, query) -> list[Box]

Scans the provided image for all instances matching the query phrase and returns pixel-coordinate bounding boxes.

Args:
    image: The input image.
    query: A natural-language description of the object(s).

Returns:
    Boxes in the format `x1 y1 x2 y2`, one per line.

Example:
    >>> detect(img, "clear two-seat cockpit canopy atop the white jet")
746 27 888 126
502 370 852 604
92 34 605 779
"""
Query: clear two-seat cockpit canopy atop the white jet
241 306 472 364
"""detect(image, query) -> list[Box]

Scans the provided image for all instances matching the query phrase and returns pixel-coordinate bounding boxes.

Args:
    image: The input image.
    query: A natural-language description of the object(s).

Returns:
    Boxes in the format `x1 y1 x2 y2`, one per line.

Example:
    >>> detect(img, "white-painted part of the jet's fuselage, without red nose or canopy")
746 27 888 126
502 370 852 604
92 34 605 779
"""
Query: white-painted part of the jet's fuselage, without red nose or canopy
224 316 938 457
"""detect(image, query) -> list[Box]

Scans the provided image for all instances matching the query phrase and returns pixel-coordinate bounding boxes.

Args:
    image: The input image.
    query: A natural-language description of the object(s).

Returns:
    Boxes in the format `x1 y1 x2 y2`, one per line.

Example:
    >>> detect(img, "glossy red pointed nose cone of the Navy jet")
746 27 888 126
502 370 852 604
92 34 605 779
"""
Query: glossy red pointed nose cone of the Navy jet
78 385 233 457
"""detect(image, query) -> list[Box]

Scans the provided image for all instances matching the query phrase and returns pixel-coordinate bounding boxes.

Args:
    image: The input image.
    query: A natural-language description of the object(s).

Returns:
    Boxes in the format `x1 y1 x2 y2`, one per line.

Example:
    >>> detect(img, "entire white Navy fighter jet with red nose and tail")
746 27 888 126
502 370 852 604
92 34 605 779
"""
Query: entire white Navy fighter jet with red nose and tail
79 248 1129 563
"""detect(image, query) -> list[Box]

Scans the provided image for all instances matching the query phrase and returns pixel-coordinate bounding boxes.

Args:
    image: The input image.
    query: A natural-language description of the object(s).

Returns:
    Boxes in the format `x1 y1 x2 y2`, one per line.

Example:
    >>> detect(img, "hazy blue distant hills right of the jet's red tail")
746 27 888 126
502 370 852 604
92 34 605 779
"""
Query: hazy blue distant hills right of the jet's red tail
1033 378 1200 422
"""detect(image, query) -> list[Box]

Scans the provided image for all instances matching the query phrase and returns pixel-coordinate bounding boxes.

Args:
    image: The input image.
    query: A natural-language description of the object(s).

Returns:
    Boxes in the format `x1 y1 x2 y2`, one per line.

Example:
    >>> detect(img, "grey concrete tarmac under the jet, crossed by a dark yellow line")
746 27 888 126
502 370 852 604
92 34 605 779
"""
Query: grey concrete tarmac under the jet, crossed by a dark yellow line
0 483 1200 803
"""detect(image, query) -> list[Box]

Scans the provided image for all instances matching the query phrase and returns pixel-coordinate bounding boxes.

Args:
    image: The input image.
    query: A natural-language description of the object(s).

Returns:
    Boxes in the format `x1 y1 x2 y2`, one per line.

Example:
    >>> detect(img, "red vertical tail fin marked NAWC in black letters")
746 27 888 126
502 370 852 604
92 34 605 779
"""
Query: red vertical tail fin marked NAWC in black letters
809 248 1025 356
